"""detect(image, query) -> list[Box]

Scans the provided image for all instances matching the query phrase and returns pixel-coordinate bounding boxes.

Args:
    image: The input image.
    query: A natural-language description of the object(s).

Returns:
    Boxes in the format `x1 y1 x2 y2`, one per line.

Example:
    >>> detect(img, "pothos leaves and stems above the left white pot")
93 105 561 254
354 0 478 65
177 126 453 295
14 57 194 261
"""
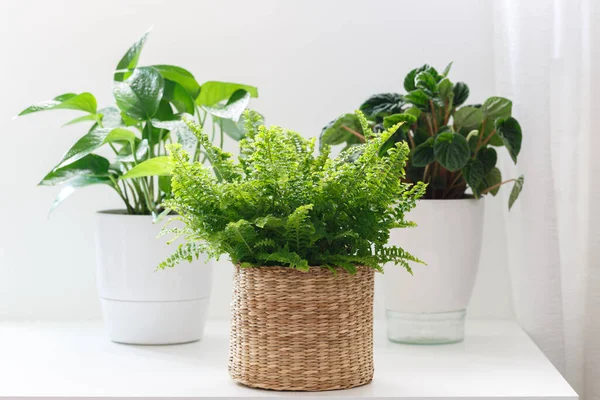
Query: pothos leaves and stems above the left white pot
18 33 258 216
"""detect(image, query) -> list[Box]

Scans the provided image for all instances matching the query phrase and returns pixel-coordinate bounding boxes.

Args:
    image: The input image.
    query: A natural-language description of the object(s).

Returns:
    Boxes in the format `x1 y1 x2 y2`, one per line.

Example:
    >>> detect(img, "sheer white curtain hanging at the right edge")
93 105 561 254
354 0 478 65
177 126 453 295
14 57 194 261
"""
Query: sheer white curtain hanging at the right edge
494 0 600 400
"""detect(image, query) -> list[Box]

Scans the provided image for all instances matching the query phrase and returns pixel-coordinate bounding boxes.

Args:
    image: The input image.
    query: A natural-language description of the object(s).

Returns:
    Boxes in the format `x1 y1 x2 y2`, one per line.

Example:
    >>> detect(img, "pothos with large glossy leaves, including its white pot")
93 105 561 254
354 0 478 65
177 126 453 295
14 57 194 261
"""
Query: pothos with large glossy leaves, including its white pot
19 34 257 344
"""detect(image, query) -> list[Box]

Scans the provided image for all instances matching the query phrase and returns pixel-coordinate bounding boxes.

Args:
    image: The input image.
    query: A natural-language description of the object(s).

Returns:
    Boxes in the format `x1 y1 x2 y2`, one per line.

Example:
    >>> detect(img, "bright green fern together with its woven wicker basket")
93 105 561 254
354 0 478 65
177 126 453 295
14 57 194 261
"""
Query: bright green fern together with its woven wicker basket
152 112 425 391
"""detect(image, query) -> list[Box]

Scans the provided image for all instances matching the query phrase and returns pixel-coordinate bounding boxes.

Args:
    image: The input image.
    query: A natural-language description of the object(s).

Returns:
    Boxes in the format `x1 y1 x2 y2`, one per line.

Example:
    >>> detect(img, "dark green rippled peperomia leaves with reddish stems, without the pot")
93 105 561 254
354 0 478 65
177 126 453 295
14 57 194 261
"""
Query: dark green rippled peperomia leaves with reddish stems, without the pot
321 63 523 209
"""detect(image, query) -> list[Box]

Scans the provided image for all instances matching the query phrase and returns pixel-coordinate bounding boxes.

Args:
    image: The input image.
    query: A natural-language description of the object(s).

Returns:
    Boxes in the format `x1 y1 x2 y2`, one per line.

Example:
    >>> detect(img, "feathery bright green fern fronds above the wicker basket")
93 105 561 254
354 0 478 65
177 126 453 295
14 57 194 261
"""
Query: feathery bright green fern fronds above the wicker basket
161 112 426 273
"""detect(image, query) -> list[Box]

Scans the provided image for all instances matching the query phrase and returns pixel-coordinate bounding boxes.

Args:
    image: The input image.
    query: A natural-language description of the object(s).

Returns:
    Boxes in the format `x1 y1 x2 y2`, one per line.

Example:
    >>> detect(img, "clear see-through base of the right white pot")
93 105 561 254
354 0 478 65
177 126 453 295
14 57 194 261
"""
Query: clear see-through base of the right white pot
386 310 467 344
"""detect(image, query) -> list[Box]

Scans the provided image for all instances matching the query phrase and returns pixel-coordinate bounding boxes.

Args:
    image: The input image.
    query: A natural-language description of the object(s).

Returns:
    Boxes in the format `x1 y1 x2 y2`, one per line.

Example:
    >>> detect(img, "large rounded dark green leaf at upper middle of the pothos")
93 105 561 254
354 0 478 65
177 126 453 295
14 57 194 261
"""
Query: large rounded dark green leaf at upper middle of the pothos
113 67 164 121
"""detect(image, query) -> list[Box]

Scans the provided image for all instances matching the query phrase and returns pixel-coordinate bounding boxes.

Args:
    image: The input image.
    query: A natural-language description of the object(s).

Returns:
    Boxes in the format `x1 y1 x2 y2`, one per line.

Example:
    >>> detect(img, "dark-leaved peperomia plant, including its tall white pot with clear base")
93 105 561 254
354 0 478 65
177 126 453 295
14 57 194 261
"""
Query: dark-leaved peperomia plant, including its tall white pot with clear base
321 61 523 344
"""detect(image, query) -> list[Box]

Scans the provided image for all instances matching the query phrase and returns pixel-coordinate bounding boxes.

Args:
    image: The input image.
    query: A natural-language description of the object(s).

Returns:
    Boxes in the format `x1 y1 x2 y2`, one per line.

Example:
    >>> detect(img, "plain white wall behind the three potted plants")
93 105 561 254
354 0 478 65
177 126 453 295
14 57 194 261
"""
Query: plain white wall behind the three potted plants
0 0 512 319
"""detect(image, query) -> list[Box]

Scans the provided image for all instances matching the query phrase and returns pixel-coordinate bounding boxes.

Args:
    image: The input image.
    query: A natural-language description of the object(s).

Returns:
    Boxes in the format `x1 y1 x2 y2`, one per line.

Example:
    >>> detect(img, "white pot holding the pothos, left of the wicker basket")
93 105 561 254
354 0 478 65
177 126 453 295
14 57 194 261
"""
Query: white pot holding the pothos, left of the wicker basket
96 211 212 344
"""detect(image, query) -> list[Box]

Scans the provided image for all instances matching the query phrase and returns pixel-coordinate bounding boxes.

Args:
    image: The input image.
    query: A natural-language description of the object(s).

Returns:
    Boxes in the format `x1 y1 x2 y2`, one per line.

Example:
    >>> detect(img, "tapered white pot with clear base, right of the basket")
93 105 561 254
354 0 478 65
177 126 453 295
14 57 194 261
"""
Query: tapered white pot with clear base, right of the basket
384 199 484 344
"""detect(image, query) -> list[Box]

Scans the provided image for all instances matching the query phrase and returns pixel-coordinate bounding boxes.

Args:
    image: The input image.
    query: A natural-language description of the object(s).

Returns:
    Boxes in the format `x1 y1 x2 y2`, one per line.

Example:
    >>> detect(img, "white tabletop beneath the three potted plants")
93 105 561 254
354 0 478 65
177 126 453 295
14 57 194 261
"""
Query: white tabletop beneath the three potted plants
0 321 577 400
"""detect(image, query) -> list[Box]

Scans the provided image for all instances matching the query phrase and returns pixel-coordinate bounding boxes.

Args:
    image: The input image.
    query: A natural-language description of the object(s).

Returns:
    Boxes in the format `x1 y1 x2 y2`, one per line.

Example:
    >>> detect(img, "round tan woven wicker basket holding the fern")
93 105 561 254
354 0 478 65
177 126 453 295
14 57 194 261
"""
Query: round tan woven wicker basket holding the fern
229 267 374 391
